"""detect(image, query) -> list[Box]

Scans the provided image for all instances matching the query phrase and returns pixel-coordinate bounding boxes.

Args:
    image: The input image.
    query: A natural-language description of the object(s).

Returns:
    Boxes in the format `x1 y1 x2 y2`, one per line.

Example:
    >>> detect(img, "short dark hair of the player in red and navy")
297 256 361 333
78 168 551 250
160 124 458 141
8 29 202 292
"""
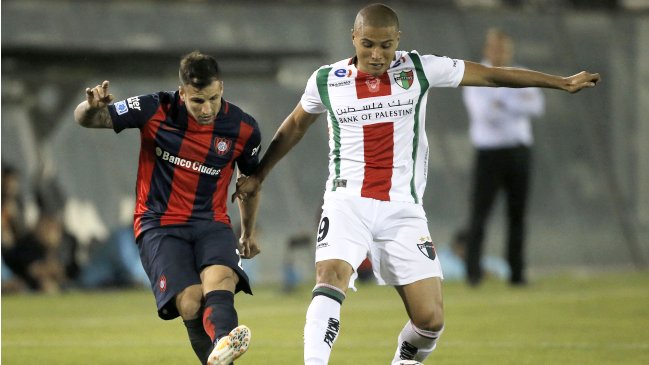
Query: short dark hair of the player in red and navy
178 51 221 89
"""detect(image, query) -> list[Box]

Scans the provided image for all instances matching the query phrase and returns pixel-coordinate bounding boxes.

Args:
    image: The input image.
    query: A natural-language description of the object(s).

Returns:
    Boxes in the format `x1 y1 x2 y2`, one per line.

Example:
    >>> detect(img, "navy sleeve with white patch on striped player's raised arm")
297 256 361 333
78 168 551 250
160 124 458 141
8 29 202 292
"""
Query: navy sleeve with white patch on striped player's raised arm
108 94 160 133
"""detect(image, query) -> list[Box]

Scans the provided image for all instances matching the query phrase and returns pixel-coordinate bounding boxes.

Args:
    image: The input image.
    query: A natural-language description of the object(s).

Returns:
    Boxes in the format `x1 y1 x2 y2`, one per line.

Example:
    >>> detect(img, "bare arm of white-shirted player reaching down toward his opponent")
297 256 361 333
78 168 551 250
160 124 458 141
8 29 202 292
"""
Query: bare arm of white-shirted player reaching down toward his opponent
232 103 318 201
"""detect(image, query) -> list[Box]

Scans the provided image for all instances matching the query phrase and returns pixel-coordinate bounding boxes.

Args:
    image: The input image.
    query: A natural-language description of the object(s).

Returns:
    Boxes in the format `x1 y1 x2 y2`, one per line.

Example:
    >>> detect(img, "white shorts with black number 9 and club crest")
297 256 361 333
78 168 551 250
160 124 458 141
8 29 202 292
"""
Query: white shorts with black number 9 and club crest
315 192 443 289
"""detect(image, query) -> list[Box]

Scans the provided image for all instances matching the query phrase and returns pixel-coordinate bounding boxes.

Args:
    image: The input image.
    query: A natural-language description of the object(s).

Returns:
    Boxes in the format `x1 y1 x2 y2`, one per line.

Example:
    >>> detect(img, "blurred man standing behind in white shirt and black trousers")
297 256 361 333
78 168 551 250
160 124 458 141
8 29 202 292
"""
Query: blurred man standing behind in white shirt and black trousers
463 28 545 285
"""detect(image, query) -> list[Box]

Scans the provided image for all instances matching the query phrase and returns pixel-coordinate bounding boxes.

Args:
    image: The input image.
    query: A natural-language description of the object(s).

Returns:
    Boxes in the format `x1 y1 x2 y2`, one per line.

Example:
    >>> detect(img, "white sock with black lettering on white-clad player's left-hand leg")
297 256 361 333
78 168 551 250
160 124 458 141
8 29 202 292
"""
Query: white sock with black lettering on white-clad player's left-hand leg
304 285 345 365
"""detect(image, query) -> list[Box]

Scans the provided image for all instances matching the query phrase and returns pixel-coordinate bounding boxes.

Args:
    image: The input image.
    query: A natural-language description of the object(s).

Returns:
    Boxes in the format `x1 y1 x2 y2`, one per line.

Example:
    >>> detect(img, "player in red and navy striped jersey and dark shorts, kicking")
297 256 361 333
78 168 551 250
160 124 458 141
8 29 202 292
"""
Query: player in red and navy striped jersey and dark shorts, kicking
74 51 261 365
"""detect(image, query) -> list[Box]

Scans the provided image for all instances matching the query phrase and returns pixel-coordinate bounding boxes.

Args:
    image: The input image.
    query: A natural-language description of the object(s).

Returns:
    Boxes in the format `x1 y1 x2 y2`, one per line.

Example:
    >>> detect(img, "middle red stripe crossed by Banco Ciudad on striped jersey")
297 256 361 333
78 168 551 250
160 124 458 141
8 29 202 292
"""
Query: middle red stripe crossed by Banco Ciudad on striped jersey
160 118 214 226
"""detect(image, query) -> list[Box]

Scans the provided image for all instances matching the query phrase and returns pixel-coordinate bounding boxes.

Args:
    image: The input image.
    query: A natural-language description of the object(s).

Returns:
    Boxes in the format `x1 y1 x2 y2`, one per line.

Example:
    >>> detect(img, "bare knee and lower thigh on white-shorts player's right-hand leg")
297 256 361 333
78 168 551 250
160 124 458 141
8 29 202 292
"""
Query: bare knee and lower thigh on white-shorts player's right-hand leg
395 277 444 331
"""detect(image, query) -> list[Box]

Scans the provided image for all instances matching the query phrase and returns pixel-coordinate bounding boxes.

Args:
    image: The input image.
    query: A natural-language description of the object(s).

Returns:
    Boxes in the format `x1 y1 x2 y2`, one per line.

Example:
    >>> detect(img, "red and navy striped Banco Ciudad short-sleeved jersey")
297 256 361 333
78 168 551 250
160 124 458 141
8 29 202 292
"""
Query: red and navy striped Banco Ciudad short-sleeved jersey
108 91 261 237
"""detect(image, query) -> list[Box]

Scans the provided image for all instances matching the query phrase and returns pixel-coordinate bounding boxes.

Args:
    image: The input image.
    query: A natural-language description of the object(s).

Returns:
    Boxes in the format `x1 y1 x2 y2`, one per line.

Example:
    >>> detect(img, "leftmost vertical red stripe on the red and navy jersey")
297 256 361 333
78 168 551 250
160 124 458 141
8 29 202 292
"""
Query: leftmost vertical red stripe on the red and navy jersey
133 109 164 237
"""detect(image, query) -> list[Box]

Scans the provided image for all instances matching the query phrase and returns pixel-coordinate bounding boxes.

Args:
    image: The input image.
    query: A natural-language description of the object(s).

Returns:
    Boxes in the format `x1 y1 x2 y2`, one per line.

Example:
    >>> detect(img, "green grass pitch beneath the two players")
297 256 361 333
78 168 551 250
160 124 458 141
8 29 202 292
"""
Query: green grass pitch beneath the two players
2 271 649 365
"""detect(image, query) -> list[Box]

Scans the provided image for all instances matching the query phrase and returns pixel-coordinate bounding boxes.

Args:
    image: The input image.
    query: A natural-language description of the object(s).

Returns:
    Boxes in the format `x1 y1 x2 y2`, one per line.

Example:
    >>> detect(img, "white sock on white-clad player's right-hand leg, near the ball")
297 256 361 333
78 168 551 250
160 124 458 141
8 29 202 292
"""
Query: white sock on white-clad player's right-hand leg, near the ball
392 321 444 364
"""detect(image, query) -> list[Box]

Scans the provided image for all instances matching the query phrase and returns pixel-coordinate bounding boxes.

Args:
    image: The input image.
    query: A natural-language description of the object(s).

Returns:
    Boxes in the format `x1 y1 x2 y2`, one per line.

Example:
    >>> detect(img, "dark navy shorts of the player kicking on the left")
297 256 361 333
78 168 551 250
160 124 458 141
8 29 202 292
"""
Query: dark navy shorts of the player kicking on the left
137 221 252 319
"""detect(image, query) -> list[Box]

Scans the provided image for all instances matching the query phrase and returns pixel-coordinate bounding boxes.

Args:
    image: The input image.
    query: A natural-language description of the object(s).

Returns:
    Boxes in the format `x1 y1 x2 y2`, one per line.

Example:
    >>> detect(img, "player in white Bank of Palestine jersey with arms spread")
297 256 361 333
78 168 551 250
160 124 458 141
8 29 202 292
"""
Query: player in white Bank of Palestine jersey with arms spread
233 4 599 365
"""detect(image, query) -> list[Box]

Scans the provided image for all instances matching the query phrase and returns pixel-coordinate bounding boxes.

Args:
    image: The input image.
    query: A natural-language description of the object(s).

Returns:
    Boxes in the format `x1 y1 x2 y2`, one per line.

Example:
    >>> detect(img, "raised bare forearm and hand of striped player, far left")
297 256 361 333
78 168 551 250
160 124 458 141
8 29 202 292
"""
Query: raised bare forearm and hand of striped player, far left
74 81 113 128
